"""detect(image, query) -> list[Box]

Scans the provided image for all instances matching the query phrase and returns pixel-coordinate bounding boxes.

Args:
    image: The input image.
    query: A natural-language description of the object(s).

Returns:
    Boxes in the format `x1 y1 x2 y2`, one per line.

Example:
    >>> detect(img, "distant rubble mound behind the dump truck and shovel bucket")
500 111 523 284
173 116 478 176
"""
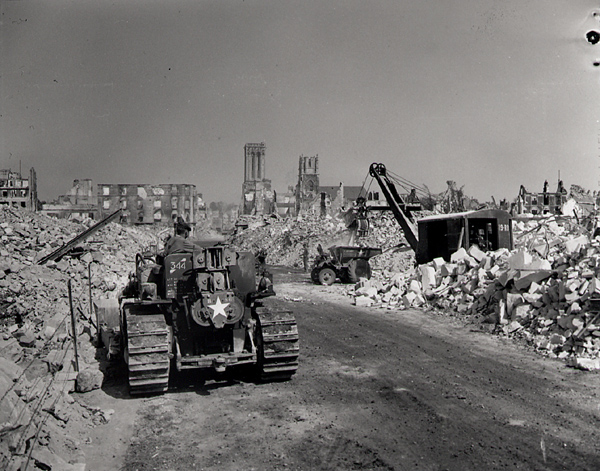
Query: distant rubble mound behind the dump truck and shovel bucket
231 215 414 270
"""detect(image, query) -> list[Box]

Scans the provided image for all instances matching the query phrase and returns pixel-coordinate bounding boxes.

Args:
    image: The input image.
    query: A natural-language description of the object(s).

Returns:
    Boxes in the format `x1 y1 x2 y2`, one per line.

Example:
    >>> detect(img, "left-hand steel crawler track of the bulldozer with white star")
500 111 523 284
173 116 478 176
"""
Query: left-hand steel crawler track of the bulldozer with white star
124 305 172 395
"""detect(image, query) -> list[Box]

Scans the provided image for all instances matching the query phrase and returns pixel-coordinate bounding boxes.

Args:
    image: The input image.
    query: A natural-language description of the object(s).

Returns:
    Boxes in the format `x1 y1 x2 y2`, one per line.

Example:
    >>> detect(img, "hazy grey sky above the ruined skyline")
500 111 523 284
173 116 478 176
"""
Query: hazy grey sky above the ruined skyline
0 0 600 202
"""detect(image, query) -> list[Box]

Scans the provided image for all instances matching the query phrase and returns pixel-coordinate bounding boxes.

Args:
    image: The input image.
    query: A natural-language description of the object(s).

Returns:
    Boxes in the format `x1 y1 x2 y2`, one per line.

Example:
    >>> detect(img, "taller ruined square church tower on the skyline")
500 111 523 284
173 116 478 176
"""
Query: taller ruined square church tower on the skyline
242 142 275 214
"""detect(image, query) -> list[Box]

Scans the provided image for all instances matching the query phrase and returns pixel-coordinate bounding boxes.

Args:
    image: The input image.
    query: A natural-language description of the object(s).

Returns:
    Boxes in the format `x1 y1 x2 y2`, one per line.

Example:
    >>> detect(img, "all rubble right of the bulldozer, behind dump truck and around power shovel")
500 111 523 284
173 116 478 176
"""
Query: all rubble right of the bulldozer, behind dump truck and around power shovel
234 212 600 369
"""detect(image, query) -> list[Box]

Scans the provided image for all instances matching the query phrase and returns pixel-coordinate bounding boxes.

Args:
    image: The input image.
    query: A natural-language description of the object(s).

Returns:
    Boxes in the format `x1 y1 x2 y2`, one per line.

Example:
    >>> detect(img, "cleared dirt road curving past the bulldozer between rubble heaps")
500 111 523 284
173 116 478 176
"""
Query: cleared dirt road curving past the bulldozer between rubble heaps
86 274 600 471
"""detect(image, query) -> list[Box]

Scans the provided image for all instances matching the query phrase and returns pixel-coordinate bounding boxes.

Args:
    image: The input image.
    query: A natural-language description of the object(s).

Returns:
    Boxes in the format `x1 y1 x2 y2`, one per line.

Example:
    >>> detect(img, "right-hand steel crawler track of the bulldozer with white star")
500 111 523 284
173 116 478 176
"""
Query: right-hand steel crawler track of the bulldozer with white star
256 306 299 381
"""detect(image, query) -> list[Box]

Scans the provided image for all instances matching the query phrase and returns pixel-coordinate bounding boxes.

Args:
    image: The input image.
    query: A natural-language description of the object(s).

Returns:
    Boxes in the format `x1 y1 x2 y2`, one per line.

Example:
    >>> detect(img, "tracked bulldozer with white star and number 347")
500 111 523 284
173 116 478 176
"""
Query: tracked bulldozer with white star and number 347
98 241 299 395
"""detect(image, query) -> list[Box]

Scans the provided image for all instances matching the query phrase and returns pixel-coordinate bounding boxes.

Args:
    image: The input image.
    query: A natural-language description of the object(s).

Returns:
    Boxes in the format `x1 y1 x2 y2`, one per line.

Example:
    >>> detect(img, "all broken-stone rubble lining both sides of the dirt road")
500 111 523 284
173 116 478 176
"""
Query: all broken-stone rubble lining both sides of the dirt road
0 208 600 470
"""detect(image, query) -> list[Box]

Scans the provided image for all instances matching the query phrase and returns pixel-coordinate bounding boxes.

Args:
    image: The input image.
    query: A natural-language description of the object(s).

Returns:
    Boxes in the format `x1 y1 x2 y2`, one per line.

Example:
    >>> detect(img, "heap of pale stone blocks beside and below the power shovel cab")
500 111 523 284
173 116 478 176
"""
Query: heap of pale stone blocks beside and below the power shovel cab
350 220 600 368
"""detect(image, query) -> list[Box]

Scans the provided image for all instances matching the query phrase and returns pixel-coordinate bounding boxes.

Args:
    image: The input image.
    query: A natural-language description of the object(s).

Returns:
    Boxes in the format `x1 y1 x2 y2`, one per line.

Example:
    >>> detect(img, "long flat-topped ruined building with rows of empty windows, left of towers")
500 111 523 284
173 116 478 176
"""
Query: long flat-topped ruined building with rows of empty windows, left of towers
98 183 206 225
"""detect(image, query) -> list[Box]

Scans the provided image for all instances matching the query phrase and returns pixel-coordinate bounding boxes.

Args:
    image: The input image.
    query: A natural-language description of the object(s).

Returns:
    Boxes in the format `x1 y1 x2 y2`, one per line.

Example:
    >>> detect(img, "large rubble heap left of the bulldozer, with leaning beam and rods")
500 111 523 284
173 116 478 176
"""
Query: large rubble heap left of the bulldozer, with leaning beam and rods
0 208 156 470
